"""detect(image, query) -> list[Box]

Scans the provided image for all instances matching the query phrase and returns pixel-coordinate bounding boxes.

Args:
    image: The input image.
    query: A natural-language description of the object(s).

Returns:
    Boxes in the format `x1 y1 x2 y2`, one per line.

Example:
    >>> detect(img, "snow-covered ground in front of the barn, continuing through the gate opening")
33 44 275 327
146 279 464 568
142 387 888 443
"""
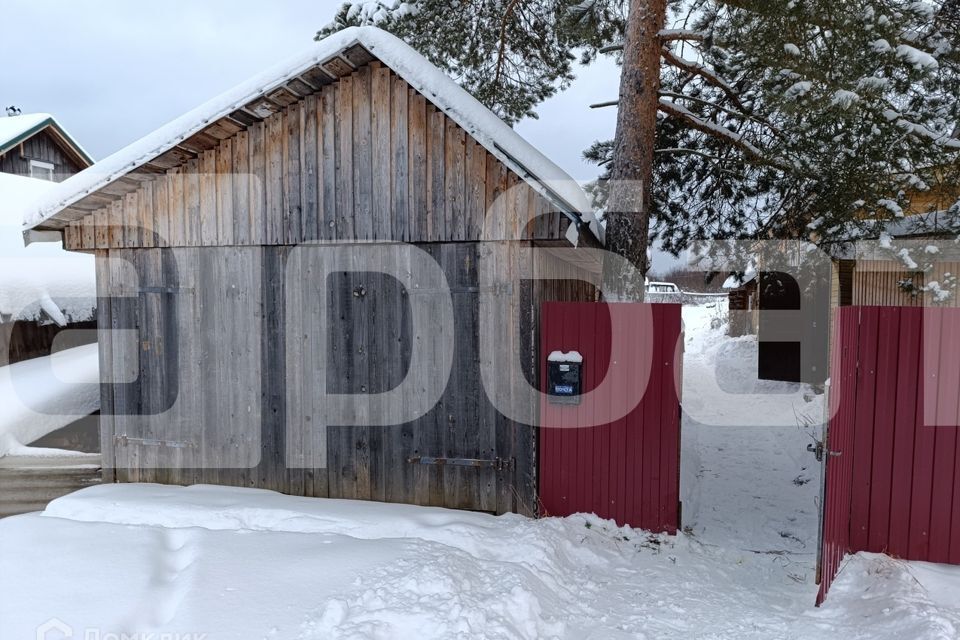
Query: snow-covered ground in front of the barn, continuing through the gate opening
0 307 960 640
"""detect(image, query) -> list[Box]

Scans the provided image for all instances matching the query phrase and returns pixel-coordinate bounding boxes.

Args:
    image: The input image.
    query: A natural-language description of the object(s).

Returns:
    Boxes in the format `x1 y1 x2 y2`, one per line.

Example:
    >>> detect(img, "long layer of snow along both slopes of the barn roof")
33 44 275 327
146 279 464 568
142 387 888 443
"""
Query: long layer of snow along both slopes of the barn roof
25 27 603 239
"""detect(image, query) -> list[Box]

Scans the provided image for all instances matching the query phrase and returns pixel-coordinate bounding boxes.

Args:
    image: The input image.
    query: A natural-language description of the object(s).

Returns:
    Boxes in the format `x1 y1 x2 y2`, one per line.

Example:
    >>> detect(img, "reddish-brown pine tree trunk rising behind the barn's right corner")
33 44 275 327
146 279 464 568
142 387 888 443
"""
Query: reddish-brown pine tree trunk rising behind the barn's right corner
603 0 667 301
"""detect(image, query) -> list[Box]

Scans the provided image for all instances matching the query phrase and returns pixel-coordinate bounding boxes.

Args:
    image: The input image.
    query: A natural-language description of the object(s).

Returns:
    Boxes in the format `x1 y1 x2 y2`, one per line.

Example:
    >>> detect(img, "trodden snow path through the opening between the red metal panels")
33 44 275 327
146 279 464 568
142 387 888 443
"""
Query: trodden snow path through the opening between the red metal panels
681 301 824 556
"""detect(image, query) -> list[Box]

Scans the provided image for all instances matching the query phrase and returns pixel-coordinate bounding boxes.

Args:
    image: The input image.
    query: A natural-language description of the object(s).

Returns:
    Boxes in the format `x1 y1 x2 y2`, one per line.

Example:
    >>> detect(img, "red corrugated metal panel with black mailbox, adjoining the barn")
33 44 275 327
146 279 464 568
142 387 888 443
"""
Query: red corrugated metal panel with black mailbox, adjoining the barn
539 302 683 533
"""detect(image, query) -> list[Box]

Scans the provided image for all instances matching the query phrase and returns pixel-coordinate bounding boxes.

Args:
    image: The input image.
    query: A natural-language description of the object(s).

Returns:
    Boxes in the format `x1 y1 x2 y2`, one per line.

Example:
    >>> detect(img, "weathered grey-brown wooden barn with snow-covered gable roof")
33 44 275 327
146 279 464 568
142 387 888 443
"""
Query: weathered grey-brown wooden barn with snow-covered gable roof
22 27 608 514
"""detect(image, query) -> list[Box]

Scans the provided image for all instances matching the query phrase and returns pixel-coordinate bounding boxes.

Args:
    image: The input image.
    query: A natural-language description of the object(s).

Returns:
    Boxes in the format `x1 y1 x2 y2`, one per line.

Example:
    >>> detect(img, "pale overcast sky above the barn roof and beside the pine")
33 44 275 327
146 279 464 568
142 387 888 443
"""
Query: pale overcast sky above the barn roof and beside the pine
0 0 684 270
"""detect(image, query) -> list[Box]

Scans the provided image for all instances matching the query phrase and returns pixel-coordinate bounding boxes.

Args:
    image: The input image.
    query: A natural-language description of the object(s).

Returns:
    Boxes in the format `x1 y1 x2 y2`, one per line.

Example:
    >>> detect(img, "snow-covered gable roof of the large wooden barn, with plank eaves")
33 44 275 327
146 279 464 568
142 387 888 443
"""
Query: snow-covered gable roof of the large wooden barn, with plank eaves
24 27 603 244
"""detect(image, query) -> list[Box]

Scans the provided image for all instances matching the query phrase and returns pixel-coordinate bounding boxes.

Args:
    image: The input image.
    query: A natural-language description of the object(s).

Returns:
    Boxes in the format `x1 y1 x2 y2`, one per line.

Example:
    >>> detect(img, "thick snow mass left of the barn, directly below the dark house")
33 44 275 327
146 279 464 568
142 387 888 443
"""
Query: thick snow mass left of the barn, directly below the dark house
0 173 97 326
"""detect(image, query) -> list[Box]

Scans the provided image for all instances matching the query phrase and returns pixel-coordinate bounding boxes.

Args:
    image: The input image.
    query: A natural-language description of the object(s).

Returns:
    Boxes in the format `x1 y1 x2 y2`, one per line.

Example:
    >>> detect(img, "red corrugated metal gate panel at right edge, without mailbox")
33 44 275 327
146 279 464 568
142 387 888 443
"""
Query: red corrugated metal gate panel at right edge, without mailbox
818 307 960 603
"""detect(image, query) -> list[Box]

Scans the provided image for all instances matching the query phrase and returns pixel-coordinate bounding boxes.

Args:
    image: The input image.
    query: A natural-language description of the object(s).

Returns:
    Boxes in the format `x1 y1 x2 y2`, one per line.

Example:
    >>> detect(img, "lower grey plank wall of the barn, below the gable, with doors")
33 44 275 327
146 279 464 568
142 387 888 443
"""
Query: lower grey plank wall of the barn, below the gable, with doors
98 242 594 514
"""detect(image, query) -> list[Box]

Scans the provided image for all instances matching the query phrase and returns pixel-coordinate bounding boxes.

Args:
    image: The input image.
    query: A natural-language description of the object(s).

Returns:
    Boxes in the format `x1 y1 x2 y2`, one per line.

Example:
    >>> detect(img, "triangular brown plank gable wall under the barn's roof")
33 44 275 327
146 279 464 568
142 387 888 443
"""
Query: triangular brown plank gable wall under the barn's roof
65 62 569 251
